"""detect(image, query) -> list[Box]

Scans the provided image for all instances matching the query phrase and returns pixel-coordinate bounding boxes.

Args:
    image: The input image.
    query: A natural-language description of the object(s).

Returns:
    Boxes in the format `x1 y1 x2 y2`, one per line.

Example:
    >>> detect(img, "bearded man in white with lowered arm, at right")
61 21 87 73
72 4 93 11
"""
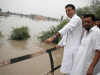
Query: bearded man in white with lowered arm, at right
71 14 100 75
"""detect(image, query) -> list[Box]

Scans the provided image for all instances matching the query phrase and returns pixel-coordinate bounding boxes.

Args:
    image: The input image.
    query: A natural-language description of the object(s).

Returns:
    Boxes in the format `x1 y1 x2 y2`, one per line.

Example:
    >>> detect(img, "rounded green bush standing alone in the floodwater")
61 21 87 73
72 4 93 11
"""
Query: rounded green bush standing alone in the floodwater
11 26 30 40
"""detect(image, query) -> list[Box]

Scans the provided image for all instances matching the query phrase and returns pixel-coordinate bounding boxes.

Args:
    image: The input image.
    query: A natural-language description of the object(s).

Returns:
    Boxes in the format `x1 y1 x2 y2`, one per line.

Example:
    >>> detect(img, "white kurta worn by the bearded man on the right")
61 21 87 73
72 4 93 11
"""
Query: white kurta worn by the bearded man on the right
71 26 100 75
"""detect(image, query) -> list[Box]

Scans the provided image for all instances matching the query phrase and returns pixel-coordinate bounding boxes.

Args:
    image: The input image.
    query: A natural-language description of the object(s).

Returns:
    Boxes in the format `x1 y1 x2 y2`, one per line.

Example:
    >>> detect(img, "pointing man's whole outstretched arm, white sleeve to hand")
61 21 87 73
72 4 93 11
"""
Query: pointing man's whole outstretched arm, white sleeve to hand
44 18 82 44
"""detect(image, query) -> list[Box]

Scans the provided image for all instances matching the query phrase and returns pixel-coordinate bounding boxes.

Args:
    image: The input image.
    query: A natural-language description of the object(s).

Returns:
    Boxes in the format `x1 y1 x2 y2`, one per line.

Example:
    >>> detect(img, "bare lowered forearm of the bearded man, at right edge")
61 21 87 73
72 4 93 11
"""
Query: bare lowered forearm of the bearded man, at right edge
87 50 100 75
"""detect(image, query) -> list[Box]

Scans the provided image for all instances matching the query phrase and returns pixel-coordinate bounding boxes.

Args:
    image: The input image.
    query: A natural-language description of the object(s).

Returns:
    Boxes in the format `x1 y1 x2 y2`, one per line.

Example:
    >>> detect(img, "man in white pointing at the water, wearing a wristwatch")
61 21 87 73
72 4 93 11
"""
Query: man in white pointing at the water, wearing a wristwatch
44 4 82 75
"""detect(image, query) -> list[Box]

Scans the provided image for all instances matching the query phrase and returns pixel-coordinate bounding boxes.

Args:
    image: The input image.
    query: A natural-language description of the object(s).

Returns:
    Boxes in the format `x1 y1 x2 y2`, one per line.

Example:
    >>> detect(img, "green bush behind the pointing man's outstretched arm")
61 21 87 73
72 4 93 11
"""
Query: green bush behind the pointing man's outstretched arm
38 20 69 44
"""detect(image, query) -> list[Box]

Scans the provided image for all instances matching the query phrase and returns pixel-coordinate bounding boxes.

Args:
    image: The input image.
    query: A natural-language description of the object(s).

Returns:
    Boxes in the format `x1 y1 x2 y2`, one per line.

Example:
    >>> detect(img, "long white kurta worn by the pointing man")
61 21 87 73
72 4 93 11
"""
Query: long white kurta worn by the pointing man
59 14 82 74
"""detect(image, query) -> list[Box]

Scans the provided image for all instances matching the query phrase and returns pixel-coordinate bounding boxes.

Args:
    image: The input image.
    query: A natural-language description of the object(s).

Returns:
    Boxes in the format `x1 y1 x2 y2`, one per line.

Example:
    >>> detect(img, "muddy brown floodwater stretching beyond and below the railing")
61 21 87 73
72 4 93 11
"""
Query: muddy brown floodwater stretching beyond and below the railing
0 16 63 75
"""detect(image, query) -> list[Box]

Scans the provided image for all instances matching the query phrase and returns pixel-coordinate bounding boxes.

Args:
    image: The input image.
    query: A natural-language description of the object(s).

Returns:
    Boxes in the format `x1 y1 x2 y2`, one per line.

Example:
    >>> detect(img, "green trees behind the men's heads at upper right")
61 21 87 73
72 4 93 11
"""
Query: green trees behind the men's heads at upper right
76 0 100 18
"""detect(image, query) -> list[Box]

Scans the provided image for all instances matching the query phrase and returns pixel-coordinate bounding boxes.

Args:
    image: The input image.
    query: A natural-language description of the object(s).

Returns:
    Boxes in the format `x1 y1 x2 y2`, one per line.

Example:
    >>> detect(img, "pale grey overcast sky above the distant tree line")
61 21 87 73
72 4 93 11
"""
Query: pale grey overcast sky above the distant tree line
0 0 91 18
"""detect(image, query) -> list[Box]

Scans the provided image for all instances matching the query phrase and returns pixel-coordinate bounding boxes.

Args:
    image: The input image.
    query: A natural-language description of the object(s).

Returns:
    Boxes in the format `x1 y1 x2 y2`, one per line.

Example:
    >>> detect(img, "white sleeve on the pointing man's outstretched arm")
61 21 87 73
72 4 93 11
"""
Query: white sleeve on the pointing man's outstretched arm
58 18 79 36
